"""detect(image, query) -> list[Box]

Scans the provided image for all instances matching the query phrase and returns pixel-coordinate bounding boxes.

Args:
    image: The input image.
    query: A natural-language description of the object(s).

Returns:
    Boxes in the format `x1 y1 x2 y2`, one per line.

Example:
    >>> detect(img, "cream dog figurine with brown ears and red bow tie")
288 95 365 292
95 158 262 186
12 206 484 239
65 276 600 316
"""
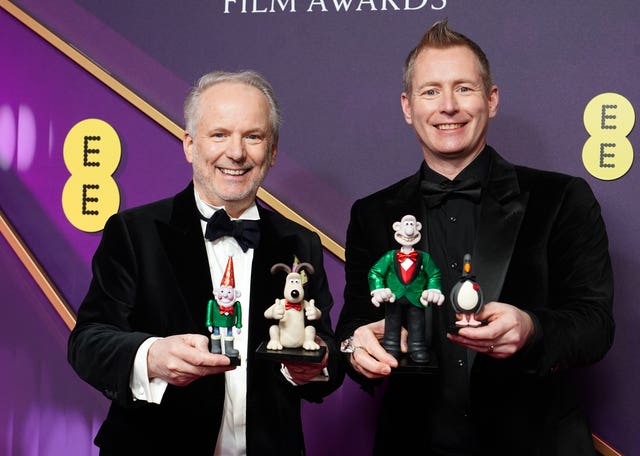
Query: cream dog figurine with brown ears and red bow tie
264 263 322 350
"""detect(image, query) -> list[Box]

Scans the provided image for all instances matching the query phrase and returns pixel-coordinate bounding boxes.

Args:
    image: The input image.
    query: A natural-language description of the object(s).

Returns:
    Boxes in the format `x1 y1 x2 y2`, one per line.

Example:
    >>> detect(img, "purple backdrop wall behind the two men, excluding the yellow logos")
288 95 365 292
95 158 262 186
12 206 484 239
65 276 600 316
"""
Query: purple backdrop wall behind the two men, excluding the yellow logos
0 0 640 455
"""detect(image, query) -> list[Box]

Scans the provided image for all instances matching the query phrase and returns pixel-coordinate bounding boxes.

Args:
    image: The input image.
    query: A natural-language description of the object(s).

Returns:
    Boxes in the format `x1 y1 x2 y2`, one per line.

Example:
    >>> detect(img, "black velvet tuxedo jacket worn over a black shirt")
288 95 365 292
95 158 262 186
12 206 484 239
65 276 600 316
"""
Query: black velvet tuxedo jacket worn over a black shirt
336 146 615 456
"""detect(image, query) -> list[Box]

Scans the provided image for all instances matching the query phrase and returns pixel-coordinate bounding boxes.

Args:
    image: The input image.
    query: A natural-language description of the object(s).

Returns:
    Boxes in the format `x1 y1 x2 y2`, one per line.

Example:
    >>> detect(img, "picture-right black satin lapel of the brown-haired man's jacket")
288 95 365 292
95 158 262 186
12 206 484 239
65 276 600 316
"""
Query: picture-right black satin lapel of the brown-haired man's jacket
471 148 529 302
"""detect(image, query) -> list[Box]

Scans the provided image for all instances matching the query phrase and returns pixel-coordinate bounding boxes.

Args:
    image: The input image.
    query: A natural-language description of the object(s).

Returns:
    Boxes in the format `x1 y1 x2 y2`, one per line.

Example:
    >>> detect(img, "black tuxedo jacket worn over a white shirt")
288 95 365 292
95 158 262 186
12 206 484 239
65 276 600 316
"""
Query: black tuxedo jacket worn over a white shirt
68 183 342 456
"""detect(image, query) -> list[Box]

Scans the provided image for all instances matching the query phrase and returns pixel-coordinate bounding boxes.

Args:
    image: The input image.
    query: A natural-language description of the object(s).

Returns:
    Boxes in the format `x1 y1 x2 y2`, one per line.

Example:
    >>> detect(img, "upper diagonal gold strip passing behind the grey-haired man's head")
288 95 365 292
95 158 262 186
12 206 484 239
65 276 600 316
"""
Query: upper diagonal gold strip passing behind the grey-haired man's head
0 0 345 262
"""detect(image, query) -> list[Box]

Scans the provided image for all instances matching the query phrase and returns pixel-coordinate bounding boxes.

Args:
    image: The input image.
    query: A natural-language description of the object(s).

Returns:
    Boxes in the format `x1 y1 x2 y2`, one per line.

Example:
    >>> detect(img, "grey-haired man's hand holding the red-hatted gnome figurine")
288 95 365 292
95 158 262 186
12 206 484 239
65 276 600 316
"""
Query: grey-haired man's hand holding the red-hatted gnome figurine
147 334 235 386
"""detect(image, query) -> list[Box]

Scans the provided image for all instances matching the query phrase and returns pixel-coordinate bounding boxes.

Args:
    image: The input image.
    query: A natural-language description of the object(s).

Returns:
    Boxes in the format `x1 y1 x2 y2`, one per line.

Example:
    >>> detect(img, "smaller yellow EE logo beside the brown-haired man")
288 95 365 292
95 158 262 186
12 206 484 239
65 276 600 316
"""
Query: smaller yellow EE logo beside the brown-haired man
582 93 635 180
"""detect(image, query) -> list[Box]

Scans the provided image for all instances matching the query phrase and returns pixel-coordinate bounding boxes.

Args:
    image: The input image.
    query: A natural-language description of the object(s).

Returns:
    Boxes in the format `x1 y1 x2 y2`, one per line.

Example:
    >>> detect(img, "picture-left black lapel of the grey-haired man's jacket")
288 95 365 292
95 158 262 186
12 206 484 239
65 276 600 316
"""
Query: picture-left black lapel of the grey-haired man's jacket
158 185 213 330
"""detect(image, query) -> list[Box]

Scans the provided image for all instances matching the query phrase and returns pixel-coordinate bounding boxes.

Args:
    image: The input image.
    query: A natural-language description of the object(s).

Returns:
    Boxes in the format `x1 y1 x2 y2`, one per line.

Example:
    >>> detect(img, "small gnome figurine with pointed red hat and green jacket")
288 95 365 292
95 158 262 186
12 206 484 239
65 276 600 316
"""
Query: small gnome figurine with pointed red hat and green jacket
207 257 242 358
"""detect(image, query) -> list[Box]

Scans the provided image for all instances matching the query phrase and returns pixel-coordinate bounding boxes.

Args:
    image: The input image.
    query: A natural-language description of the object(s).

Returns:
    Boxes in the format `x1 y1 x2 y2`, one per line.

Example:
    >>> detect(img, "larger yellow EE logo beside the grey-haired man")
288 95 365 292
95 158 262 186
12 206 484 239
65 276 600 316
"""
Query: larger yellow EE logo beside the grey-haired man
62 119 122 233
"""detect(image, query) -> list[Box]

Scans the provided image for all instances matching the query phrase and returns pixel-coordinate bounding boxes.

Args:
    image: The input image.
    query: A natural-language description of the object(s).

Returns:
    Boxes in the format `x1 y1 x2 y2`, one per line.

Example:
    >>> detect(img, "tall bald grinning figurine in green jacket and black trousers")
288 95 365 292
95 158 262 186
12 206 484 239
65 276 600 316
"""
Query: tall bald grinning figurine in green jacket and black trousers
368 215 444 364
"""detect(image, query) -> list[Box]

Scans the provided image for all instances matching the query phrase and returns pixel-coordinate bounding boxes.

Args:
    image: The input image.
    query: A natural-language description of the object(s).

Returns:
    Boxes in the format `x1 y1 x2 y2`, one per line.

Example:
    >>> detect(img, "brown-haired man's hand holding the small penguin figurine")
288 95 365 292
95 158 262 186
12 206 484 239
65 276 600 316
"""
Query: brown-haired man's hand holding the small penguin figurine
447 301 534 359
